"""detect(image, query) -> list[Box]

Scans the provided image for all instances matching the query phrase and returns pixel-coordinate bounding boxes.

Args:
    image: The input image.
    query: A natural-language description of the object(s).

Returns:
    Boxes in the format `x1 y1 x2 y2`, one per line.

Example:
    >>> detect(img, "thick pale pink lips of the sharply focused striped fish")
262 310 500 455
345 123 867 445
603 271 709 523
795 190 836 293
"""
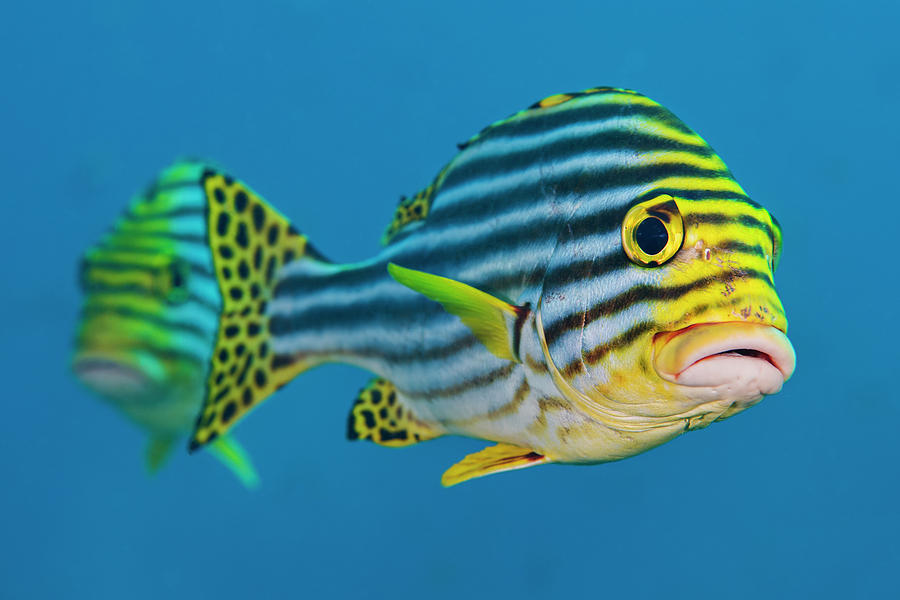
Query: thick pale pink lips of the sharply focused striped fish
653 322 796 396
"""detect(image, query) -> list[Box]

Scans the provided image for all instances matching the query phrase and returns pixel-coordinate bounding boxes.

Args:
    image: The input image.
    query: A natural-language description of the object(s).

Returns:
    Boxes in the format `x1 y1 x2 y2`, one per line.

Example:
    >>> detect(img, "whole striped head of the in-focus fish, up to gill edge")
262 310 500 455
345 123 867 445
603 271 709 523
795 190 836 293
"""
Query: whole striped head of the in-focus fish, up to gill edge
538 97 795 440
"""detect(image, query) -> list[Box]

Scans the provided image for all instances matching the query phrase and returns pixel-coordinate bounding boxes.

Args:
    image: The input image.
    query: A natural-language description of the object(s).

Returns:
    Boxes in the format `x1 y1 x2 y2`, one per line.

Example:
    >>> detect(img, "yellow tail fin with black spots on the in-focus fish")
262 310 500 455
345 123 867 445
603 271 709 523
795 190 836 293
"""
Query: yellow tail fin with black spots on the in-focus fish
188 164 325 452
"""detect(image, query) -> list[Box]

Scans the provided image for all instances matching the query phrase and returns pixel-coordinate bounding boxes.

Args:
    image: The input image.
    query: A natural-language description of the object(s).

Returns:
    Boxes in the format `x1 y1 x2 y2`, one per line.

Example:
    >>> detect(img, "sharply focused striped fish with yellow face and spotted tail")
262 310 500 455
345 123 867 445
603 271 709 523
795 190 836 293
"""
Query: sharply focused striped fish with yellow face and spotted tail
107 87 796 486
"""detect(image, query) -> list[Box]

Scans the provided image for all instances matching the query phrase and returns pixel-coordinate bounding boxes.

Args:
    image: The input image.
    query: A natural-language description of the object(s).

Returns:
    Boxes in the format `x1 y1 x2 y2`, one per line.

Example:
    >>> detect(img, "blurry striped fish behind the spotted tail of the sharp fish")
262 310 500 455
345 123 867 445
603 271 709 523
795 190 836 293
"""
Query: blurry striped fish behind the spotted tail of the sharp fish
71 166 259 489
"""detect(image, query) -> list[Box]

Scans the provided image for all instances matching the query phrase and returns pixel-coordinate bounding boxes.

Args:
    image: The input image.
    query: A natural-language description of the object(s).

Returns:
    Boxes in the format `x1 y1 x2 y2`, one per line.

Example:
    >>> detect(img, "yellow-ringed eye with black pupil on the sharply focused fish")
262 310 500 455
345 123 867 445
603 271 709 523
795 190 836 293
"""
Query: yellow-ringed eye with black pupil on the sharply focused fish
622 194 684 267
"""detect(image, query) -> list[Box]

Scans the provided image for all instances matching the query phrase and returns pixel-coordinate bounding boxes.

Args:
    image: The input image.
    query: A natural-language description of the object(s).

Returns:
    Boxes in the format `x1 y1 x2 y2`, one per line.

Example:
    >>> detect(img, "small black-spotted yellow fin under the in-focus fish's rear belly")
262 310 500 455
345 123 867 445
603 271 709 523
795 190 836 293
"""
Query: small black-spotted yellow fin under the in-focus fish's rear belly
347 377 442 448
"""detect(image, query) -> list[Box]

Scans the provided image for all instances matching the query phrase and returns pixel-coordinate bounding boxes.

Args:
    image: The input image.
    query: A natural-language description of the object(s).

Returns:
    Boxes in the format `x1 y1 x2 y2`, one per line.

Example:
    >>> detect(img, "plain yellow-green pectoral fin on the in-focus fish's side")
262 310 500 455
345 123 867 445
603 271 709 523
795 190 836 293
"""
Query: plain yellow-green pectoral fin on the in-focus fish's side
388 263 528 362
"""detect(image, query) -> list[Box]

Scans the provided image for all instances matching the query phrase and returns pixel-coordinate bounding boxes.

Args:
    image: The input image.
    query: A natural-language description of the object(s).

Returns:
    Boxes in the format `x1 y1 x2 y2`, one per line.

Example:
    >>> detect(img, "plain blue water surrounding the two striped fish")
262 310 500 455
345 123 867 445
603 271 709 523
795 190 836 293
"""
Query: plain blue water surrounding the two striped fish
0 0 900 600
